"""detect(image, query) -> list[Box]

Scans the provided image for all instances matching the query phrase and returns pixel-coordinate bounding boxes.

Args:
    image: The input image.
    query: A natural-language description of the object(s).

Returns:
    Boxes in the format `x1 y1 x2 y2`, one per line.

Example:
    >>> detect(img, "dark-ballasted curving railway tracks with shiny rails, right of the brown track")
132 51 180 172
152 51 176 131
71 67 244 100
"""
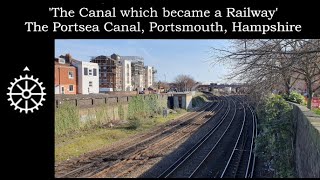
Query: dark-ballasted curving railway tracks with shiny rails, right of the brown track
158 95 256 178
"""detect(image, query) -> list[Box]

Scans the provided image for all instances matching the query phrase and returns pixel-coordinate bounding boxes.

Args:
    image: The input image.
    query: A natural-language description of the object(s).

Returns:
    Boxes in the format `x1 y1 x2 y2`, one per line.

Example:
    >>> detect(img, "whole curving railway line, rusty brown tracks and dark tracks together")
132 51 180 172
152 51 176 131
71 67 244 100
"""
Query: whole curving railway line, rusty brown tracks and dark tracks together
56 93 257 178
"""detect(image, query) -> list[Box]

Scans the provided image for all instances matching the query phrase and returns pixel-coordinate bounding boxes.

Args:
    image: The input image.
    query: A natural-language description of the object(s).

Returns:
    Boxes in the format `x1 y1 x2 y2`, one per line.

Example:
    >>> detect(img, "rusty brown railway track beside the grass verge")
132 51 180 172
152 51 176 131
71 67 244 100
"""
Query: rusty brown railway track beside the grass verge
58 92 221 177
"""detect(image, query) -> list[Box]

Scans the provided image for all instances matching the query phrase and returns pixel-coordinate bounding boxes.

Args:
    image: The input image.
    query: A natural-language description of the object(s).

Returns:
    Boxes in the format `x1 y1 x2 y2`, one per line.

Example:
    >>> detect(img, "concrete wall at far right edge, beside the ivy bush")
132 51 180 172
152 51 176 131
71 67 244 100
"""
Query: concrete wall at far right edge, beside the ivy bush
293 104 320 178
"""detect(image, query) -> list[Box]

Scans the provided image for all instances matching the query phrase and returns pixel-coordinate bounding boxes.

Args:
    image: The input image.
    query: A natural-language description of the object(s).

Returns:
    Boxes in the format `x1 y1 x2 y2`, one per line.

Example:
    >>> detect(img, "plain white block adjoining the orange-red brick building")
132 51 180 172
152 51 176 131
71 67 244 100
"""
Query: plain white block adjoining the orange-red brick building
71 59 99 94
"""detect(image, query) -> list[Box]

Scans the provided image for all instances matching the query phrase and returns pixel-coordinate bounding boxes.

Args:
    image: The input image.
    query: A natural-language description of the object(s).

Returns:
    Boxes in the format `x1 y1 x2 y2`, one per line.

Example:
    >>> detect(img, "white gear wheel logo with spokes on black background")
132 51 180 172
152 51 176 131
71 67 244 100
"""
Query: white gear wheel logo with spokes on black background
7 75 46 114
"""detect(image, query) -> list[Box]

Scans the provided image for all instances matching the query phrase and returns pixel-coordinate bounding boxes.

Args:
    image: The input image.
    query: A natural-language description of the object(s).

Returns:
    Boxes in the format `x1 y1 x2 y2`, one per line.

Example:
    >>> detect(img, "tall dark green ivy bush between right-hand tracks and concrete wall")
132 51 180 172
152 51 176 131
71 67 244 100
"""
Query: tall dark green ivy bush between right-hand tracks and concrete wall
256 95 294 177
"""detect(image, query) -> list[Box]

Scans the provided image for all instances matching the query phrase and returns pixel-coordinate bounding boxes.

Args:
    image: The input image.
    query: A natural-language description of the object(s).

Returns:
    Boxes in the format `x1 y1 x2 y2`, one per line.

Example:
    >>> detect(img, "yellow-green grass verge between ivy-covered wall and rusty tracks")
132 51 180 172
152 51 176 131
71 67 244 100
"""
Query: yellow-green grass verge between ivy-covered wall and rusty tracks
55 110 186 163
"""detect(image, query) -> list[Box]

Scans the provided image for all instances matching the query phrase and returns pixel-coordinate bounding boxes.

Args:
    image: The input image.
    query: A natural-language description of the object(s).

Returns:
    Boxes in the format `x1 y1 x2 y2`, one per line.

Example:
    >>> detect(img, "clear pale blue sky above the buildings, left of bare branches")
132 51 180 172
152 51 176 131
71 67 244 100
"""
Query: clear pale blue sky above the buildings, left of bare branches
55 39 229 83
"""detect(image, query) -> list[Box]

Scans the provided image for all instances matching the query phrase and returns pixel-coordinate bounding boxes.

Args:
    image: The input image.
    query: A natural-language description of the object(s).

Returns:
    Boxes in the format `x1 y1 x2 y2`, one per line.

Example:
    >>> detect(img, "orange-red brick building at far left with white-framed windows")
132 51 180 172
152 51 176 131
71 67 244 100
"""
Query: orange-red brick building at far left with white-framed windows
54 57 77 94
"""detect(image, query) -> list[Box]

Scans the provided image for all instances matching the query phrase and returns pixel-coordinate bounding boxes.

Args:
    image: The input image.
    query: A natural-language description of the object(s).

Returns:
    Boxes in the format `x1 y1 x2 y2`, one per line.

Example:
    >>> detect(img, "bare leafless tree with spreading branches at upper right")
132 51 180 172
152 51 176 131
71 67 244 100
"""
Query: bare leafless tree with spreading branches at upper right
211 39 320 108
